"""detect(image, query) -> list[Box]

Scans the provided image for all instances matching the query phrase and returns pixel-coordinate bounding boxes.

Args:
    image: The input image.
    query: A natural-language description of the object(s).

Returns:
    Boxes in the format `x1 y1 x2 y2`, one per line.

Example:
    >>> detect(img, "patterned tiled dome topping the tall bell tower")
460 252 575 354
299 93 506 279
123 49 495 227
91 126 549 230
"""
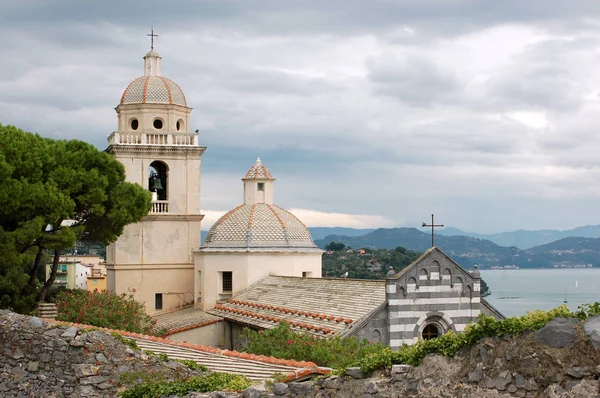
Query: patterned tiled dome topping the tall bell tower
121 75 187 106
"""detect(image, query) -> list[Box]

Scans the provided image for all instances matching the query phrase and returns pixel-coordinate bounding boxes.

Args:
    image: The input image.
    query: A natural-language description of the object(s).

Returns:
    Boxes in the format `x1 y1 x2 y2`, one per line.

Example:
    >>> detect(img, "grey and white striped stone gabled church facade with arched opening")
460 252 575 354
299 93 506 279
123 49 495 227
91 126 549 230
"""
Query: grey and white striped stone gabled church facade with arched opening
386 247 481 349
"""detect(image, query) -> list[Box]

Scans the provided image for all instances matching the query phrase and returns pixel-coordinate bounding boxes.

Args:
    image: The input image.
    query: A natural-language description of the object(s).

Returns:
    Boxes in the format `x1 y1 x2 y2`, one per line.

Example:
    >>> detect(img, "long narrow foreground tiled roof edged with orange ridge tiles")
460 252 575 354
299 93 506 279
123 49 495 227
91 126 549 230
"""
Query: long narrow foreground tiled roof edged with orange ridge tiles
49 321 331 381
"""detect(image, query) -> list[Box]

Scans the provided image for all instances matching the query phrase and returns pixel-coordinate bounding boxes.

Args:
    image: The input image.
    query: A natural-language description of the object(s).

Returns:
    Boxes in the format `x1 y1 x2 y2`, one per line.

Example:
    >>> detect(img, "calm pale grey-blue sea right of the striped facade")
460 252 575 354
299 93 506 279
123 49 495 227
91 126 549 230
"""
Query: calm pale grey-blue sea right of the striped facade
481 268 600 317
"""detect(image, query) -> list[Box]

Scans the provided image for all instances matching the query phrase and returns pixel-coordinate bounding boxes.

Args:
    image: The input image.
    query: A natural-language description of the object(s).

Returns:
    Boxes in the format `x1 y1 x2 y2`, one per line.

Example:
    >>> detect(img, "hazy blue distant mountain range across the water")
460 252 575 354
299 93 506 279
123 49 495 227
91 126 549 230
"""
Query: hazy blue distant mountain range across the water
315 228 600 268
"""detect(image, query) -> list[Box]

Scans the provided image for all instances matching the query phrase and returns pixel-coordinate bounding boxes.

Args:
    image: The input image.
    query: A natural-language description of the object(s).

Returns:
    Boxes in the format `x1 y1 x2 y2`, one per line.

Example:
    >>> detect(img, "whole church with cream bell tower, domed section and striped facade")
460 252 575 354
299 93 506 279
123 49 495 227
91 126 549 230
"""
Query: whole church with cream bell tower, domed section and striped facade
106 42 502 349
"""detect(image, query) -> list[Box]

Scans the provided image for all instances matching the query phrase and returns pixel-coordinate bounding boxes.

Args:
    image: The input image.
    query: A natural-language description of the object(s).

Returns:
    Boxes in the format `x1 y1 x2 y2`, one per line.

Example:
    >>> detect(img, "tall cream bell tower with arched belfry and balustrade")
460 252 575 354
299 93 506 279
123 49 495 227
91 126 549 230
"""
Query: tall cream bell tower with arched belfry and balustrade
106 42 206 313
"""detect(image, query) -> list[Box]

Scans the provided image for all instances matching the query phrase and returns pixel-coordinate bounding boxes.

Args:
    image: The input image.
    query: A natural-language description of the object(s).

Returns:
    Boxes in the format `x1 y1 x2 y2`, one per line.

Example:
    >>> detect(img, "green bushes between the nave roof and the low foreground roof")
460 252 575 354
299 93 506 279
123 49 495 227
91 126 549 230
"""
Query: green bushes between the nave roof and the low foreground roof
242 323 383 369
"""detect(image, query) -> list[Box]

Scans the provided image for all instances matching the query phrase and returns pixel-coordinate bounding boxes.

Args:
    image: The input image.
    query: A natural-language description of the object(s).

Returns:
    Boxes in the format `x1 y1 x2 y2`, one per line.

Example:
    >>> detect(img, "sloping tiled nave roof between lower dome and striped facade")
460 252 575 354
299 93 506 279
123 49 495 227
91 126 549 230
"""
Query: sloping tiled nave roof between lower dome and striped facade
209 275 385 337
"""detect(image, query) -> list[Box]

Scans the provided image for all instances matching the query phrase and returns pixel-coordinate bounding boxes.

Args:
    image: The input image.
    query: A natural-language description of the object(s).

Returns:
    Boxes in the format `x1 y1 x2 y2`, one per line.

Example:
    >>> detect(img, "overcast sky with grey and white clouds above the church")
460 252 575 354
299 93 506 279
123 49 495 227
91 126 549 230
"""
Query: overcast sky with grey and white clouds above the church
0 0 600 232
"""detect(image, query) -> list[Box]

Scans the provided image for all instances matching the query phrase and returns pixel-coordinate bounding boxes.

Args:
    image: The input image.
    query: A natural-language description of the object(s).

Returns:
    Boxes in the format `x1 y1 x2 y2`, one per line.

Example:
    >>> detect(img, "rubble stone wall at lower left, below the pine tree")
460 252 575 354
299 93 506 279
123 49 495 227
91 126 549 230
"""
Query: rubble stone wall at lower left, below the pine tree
0 310 202 398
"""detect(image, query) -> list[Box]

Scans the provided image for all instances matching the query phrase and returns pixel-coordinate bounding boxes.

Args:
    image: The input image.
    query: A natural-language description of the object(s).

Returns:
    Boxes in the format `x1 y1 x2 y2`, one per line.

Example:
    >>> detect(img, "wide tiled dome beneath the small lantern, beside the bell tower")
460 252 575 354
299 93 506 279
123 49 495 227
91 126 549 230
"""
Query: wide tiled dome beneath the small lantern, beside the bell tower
202 203 317 249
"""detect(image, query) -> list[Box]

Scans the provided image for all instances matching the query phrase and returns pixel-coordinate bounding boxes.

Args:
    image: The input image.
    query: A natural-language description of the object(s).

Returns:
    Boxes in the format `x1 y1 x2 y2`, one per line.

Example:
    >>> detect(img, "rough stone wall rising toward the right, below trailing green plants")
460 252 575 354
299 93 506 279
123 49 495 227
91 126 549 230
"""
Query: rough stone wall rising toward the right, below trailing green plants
187 315 600 398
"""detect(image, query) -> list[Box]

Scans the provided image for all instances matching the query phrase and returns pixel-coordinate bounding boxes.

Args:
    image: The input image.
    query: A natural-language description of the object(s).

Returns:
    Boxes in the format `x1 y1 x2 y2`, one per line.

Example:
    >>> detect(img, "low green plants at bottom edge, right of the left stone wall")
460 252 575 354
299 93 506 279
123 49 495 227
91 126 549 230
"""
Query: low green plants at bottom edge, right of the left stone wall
120 372 252 398
